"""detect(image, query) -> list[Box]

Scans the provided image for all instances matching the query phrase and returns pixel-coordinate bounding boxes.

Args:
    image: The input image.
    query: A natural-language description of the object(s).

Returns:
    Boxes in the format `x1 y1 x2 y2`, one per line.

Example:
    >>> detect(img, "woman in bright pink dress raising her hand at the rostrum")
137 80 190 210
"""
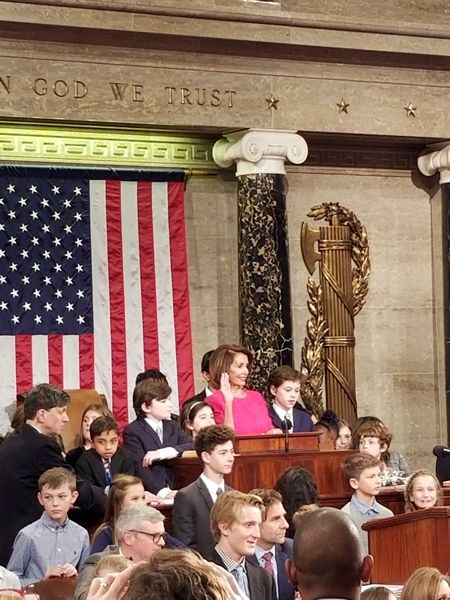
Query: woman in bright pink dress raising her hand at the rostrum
205 344 282 435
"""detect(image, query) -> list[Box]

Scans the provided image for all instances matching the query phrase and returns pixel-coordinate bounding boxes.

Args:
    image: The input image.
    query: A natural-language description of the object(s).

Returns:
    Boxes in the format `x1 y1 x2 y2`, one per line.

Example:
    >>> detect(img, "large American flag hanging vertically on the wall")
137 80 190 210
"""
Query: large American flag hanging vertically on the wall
0 167 193 432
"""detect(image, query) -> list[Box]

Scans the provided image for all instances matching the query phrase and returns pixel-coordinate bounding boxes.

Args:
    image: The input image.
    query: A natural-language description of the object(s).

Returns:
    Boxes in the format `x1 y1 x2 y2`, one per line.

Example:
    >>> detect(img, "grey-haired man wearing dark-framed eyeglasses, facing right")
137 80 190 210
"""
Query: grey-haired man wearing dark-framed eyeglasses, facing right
74 504 166 600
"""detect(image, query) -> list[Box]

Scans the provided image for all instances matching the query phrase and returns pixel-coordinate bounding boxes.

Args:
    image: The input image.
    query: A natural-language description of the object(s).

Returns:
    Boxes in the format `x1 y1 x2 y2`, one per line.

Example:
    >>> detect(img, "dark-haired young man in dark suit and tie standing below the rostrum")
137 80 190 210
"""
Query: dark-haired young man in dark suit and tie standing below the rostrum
172 425 234 558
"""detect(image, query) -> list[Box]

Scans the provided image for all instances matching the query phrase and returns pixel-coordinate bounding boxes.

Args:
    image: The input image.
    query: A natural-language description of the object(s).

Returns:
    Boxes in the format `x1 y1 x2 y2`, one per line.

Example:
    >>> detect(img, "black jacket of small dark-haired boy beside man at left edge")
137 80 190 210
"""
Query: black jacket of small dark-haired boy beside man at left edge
75 448 136 488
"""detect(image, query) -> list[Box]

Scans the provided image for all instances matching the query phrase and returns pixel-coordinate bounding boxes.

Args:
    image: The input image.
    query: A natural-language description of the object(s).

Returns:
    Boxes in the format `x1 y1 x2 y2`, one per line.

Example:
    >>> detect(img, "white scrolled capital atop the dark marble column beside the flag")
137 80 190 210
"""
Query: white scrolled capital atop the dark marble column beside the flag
213 129 308 177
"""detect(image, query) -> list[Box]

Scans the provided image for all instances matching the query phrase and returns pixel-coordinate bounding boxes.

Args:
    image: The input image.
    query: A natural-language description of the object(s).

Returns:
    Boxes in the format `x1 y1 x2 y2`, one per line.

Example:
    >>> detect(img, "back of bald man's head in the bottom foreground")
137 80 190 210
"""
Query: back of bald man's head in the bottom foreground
288 508 373 600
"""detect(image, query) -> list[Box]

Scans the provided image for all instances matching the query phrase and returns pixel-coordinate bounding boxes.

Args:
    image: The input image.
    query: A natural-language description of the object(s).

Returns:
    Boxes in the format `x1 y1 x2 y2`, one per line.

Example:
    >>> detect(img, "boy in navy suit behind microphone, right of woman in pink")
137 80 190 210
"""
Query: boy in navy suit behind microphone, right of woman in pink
269 365 314 433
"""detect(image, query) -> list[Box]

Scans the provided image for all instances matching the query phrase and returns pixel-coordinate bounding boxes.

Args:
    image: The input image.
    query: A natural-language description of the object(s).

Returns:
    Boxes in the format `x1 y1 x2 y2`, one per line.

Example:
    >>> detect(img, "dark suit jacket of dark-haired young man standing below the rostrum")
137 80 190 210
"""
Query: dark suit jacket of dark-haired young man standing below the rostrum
172 477 231 558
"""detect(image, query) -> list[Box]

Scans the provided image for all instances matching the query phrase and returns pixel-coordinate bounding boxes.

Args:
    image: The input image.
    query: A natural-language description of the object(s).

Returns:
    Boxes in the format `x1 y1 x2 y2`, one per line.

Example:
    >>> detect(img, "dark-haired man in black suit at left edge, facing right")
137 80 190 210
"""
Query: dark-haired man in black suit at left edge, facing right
0 383 105 565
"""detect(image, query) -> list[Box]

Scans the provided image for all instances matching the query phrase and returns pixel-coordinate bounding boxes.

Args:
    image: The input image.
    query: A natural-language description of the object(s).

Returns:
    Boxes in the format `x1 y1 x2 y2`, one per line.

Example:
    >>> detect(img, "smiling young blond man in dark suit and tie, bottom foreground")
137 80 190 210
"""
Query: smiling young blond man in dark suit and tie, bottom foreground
210 490 276 600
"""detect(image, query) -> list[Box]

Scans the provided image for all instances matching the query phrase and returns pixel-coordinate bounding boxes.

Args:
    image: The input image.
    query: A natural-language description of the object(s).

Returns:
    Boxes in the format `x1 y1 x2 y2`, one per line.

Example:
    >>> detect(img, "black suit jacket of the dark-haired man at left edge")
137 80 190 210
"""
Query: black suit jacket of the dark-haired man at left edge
0 424 105 566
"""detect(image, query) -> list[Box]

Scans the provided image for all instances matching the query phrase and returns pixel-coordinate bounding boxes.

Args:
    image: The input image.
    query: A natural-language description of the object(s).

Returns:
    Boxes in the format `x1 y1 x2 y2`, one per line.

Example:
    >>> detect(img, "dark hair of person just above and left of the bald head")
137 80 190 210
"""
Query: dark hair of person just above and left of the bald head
274 466 318 537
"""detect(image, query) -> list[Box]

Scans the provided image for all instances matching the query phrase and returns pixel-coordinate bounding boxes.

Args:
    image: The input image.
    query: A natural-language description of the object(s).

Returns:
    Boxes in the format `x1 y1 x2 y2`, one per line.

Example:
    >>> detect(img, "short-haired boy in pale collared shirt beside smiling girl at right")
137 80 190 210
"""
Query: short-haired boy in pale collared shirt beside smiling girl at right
341 452 394 554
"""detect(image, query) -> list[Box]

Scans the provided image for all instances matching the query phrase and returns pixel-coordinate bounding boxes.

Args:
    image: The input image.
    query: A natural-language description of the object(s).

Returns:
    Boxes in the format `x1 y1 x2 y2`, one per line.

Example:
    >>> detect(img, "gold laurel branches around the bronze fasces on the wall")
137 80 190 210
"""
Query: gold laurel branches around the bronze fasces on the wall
300 202 370 417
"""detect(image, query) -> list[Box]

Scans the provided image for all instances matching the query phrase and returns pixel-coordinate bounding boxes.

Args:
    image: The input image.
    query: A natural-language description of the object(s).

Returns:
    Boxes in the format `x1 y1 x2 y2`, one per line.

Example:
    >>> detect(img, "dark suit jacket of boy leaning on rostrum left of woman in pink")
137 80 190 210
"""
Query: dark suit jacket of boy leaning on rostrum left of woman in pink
123 417 194 494
